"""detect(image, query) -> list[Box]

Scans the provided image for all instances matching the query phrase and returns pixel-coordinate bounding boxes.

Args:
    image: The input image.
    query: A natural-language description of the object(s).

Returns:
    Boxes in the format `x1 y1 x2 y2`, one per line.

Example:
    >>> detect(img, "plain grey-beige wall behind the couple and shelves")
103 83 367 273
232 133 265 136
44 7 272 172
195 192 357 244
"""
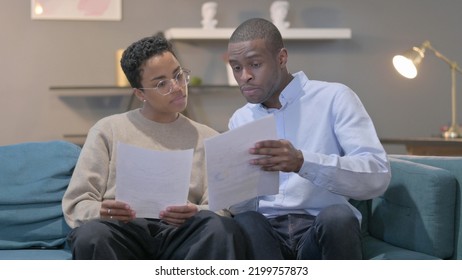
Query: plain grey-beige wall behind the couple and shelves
0 0 462 152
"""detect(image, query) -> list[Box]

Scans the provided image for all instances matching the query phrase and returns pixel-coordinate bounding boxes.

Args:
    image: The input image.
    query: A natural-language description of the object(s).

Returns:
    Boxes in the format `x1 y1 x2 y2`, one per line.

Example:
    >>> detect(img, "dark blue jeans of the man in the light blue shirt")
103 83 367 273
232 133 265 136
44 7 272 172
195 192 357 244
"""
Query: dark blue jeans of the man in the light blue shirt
234 205 362 260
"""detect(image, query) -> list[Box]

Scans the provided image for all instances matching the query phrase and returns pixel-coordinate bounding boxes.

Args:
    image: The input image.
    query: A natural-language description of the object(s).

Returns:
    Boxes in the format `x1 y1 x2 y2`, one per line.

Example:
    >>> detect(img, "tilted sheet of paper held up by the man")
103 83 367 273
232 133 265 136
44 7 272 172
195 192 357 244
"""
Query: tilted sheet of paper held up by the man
204 115 279 211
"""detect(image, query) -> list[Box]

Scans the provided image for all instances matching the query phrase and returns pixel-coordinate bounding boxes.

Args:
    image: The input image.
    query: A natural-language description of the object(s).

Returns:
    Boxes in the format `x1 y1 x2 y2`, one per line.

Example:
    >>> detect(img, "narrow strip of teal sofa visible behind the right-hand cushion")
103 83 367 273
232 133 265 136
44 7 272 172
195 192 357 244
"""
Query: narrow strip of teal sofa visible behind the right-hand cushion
391 155 462 259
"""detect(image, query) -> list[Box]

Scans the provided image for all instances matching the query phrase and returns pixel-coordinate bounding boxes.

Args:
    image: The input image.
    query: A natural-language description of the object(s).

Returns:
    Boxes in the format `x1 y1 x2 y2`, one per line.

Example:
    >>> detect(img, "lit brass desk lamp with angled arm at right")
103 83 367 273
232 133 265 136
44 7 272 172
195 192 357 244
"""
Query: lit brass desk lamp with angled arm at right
393 41 462 138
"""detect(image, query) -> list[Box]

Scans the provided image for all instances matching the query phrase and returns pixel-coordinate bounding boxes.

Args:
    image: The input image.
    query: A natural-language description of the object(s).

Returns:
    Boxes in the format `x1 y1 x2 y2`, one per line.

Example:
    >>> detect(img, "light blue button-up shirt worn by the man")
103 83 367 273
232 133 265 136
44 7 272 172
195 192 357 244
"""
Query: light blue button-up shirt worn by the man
229 72 391 220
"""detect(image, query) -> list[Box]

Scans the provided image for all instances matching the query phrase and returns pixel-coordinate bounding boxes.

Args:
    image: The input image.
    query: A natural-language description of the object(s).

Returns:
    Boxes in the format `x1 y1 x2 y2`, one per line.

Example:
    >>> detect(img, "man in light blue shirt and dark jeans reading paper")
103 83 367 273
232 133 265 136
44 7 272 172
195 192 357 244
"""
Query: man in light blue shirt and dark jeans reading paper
228 18 391 259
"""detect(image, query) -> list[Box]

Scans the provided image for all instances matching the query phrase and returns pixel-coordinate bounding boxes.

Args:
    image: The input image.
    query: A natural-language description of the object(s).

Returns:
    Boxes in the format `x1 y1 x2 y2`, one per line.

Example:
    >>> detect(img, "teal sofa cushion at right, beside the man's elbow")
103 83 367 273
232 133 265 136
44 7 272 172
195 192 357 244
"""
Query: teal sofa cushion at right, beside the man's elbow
368 158 456 259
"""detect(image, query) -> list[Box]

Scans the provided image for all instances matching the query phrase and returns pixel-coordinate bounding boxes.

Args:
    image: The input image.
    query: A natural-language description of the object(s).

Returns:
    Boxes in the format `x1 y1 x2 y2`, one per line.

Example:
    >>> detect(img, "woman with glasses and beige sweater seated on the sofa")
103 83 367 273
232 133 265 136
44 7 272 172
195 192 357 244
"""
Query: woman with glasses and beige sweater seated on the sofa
63 35 246 259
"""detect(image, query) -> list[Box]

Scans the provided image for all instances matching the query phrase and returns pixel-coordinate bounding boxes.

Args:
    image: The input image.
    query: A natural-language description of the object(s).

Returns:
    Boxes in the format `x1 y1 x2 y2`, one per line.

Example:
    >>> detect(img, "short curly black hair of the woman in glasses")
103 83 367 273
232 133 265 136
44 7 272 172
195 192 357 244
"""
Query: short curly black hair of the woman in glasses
120 33 176 88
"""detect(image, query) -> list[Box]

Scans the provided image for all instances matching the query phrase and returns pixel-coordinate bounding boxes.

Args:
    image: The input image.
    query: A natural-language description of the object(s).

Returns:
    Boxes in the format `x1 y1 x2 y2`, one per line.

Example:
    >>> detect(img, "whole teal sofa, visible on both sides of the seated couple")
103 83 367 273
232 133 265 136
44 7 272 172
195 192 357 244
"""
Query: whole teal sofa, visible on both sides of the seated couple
0 141 462 260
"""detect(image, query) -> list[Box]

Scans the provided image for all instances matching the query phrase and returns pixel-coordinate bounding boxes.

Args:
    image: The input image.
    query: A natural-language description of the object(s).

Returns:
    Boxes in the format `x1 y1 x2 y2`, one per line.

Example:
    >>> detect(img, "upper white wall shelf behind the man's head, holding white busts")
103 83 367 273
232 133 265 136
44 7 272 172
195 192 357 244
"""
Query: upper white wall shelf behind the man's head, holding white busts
164 28 351 40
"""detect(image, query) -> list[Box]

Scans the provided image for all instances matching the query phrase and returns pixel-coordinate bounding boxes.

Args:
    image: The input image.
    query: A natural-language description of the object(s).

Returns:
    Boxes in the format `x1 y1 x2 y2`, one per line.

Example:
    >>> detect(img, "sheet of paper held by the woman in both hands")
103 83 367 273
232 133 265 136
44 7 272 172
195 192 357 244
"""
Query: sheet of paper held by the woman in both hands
116 142 193 218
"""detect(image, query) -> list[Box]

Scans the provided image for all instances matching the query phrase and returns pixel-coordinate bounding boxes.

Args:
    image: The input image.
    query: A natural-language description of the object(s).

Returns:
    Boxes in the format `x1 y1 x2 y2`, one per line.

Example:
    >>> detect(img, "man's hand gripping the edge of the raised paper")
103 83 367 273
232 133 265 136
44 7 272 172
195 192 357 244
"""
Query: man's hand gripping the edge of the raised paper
249 140 303 172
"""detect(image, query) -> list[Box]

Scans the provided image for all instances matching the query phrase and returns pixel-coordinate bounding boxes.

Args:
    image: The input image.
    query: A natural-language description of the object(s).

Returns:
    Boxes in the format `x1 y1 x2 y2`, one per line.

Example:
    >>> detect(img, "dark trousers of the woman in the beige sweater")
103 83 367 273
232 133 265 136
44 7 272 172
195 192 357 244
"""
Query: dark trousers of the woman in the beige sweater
68 210 246 260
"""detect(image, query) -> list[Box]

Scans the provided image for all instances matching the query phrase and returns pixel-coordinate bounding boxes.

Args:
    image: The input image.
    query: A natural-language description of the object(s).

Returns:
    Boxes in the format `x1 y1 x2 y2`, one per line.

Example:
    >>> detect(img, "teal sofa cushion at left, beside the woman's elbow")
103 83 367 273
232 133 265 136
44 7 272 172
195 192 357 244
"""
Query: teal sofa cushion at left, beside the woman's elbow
0 141 80 250
